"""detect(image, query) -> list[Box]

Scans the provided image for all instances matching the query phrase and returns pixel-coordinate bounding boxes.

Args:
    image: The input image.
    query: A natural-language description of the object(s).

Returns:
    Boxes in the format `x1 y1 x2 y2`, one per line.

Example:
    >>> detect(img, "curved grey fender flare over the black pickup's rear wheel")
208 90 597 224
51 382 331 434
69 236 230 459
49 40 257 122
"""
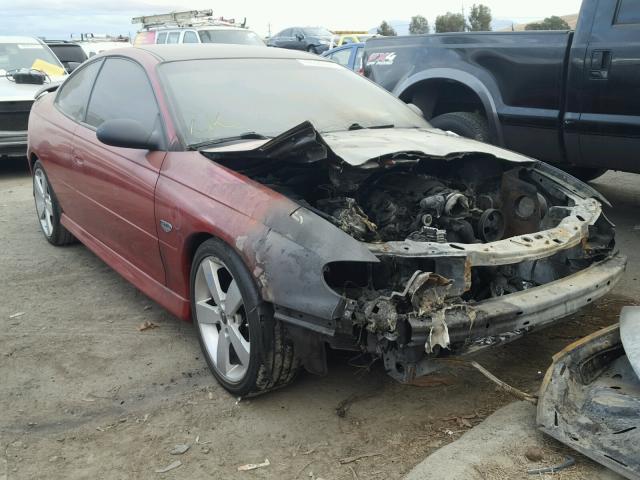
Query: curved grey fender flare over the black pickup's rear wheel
391 68 504 146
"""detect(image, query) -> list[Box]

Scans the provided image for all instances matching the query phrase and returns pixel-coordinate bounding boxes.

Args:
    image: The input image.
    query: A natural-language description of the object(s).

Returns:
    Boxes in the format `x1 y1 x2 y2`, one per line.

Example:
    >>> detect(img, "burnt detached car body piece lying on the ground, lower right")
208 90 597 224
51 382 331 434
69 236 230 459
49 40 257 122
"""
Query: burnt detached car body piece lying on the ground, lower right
537 307 640 480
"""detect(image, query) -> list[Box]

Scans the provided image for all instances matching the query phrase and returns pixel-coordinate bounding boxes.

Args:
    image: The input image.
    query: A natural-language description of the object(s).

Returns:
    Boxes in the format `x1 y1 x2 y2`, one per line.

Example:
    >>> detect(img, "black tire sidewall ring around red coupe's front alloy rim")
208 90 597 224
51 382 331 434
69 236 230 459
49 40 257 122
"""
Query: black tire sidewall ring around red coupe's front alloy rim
190 239 268 396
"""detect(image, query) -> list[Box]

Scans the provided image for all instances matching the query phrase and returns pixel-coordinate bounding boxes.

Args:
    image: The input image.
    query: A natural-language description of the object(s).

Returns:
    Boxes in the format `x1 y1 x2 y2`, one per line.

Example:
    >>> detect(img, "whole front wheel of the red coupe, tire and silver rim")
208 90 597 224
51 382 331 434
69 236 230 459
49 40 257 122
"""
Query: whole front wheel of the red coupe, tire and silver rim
191 239 300 397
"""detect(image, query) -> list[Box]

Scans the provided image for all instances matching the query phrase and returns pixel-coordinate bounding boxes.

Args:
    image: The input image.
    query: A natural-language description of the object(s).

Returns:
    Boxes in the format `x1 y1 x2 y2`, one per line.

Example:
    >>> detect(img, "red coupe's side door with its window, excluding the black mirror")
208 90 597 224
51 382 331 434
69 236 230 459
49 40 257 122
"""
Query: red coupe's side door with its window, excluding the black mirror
72 58 166 284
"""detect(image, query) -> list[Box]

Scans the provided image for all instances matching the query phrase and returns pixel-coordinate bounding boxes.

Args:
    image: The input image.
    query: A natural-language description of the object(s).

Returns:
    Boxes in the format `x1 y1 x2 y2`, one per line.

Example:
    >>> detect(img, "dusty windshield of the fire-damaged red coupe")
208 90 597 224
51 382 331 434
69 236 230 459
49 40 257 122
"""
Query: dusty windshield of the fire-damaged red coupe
159 58 428 145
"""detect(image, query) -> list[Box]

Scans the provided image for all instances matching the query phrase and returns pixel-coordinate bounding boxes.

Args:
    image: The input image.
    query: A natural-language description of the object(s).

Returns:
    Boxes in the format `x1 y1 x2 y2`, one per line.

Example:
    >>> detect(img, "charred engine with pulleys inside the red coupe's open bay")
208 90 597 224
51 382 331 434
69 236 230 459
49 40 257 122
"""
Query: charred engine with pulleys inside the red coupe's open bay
316 172 516 243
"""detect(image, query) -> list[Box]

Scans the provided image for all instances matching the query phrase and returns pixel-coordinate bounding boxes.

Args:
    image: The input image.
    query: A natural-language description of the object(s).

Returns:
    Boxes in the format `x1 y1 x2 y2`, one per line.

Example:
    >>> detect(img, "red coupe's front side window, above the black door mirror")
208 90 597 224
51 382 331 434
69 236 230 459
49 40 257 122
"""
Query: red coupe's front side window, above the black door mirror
85 58 159 128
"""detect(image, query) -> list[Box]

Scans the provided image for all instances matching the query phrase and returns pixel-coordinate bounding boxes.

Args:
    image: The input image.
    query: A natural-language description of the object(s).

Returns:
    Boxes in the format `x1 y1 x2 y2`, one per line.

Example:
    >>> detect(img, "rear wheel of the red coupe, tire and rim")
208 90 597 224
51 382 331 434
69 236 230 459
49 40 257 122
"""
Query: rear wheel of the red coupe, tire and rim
33 160 76 247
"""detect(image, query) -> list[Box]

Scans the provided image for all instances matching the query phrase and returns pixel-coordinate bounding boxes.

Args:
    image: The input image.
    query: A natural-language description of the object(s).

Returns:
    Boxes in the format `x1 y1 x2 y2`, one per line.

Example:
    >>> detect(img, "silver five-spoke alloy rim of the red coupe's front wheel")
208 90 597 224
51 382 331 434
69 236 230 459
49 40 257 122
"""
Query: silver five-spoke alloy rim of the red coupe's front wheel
194 256 251 383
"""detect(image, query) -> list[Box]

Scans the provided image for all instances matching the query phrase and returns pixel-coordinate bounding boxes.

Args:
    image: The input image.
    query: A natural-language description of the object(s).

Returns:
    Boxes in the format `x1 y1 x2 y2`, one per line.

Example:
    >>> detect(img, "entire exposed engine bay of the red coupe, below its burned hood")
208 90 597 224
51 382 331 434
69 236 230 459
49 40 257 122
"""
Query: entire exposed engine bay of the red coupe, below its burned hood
242 157 547 243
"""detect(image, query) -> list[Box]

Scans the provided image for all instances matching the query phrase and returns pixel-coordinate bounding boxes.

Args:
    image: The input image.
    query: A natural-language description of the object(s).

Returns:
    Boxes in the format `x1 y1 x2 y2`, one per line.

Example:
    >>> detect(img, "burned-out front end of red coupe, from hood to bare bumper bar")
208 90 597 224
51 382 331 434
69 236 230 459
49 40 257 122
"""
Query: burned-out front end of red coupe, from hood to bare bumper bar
205 124 626 381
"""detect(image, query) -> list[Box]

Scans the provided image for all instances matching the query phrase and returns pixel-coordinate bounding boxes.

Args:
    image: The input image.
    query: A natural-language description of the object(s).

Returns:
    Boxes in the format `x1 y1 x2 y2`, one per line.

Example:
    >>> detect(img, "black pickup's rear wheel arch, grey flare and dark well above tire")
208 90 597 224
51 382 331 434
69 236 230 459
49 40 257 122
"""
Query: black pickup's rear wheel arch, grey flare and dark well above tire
392 68 504 145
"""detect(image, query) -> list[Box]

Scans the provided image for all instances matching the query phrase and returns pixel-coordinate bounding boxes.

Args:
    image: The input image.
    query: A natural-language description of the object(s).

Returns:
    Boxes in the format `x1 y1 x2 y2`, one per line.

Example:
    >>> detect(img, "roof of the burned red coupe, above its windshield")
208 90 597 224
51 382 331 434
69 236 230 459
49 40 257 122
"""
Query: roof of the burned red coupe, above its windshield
132 44 330 62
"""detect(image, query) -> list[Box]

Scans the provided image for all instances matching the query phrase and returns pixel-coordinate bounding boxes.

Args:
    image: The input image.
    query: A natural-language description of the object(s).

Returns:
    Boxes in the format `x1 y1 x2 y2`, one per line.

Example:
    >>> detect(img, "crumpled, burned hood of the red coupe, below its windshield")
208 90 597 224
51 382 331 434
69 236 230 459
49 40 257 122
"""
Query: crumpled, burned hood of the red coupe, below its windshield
201 122 535 167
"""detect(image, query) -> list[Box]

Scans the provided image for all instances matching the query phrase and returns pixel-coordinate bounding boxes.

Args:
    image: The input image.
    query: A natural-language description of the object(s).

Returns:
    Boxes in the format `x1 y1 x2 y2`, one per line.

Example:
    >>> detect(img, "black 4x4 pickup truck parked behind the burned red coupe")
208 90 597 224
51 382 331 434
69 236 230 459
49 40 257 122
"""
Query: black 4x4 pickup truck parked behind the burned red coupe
364 0 640 180
